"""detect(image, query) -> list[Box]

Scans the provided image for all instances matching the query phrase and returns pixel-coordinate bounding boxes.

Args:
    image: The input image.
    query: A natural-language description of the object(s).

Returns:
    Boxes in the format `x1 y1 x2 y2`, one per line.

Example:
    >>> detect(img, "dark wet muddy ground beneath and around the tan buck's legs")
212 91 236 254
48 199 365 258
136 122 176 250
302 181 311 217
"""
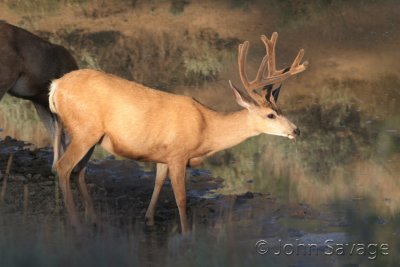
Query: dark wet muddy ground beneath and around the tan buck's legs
0 138 343 237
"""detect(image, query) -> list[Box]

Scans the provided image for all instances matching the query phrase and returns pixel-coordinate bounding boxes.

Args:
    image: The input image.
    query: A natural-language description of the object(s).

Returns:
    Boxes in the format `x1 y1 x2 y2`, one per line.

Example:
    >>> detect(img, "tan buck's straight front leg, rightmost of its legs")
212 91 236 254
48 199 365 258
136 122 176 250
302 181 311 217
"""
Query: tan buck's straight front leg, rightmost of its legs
169 163 190 234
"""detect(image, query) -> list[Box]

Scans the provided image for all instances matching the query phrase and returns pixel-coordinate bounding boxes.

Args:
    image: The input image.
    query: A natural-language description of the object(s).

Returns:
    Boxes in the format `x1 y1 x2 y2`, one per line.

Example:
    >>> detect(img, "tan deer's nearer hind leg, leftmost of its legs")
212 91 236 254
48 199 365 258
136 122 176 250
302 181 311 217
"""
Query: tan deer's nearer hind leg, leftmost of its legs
56 138 99 228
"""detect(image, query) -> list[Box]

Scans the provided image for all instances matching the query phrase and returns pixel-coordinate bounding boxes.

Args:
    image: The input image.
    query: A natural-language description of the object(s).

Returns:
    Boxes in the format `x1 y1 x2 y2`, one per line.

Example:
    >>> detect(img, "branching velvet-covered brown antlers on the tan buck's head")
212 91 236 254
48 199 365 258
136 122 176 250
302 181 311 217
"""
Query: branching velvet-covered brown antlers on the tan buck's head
231 32 308 108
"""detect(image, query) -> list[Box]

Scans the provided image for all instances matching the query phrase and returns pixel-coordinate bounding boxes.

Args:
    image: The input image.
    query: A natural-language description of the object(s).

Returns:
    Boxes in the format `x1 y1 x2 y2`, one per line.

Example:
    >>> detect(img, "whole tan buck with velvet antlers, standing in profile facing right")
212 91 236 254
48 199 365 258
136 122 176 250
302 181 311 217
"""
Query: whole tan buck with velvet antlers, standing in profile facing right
49 33 307 233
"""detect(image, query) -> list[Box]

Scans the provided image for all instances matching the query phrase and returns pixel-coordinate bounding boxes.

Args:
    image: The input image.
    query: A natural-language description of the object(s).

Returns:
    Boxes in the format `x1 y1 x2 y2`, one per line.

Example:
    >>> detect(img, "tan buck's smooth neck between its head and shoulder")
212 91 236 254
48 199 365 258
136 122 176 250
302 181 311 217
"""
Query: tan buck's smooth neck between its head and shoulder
208 109 260 152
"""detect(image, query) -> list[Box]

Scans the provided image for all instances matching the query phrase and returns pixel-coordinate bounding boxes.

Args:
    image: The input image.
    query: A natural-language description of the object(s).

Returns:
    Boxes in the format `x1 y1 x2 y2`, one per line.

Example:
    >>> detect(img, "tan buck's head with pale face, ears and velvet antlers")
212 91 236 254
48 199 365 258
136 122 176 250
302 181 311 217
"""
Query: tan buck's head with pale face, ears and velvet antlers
229 32 308 139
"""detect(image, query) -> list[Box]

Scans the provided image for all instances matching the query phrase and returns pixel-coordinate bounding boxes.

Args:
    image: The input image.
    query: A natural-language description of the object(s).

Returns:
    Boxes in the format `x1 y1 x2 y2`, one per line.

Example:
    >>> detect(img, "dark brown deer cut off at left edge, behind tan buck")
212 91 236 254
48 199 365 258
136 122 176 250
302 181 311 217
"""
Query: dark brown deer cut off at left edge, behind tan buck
0 21 78 158
